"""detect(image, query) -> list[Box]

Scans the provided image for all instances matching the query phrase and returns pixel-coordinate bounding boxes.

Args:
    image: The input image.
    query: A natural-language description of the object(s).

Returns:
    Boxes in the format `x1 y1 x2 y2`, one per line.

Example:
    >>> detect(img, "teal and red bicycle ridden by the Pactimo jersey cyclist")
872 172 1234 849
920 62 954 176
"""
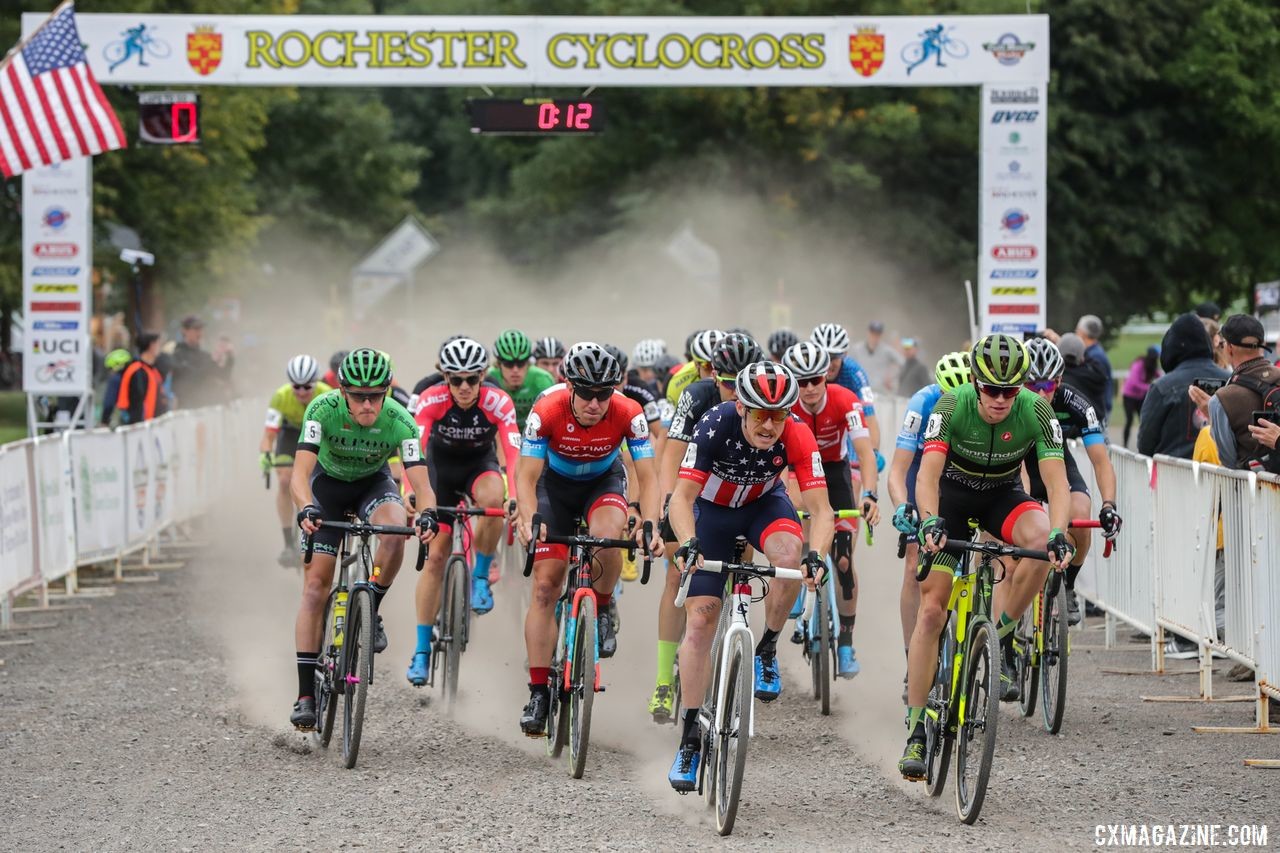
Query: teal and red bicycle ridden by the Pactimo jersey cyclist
525 514 653 779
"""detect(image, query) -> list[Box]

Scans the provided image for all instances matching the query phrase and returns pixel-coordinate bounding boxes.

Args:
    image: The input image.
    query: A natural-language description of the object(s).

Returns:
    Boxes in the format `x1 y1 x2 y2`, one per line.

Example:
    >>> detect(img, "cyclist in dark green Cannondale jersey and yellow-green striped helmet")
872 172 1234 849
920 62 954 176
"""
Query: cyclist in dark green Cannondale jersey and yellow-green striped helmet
897 333 1071 779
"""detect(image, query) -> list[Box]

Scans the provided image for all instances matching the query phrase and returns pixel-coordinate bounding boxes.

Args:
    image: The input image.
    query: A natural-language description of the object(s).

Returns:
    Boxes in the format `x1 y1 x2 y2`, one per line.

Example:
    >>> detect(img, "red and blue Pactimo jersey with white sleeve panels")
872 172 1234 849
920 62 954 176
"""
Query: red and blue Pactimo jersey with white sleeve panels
520 387 653 480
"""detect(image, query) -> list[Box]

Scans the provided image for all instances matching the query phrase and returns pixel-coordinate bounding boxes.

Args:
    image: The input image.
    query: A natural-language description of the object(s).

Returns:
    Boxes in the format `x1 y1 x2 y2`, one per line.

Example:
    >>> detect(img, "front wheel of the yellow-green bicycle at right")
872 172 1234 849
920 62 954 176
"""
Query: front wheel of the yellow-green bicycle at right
956 620 1000 825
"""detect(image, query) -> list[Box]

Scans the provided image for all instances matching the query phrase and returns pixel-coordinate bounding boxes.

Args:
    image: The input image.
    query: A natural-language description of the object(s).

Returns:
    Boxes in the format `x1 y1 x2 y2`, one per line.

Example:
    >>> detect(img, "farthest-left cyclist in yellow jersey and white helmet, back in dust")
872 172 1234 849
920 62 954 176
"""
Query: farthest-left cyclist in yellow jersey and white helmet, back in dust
257 355 333 567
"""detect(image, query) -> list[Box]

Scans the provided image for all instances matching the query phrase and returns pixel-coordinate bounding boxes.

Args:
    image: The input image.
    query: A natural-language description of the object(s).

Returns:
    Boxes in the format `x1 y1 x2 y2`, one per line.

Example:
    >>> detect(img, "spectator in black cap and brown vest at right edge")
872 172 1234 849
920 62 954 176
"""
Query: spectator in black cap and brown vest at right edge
1208 314 1280 469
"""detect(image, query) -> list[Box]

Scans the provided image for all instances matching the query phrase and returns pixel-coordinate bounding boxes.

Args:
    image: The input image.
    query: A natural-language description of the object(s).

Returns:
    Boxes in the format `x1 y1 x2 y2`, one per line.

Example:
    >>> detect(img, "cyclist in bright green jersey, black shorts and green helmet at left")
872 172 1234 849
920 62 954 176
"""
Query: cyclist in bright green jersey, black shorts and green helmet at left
289 348 438 730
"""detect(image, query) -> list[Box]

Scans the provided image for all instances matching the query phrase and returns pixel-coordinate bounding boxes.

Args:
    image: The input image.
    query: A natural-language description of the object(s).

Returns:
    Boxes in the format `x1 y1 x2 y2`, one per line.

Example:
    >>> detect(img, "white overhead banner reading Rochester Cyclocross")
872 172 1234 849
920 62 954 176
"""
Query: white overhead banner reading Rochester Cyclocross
22 13 1050 87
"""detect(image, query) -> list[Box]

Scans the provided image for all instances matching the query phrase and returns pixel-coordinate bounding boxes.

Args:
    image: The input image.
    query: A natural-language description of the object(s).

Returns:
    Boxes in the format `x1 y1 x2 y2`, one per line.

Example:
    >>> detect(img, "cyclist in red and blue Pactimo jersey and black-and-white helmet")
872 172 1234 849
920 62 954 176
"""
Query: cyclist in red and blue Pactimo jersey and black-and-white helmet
516 342 658 738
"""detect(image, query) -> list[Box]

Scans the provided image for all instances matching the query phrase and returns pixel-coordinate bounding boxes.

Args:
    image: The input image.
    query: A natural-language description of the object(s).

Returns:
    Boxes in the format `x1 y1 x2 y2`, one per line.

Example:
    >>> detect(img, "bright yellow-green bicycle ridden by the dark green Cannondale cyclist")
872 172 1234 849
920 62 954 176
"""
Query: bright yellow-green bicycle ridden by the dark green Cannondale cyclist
915 519 1048 824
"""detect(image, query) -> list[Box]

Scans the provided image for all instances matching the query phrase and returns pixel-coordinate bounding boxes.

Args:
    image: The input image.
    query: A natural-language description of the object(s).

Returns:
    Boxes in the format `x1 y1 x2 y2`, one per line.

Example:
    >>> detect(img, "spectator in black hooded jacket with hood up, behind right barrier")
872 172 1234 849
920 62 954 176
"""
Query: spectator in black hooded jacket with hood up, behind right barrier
1138 314 1228 459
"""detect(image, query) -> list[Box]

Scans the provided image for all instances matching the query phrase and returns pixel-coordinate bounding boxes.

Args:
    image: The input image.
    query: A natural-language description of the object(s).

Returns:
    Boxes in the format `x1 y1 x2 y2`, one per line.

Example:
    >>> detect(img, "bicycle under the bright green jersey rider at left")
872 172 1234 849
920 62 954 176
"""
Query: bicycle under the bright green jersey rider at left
303 516 426 768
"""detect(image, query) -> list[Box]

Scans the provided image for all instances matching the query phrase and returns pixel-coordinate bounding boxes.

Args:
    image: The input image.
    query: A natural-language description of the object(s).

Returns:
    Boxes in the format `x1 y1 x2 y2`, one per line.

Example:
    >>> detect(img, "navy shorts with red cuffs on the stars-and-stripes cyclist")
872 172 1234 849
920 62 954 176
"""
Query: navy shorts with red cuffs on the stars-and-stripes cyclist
687 484 804 598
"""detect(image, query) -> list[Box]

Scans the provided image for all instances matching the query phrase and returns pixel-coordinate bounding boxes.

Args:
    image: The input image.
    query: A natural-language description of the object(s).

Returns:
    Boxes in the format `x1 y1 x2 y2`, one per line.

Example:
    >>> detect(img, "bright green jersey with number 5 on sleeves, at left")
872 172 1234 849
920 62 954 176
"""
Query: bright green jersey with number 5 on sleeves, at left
298 391 424 482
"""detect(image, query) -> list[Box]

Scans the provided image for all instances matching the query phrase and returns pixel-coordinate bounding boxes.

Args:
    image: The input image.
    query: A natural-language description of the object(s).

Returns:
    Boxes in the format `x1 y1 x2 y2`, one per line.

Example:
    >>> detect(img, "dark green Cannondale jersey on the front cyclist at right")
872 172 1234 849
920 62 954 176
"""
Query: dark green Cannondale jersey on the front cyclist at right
924 384 1062 491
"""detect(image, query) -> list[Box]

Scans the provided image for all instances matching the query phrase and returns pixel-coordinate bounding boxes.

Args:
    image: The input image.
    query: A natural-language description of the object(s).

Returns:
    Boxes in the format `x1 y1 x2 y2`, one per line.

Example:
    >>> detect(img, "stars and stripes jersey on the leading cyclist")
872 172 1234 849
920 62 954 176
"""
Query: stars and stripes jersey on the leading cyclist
680 401 827 506
